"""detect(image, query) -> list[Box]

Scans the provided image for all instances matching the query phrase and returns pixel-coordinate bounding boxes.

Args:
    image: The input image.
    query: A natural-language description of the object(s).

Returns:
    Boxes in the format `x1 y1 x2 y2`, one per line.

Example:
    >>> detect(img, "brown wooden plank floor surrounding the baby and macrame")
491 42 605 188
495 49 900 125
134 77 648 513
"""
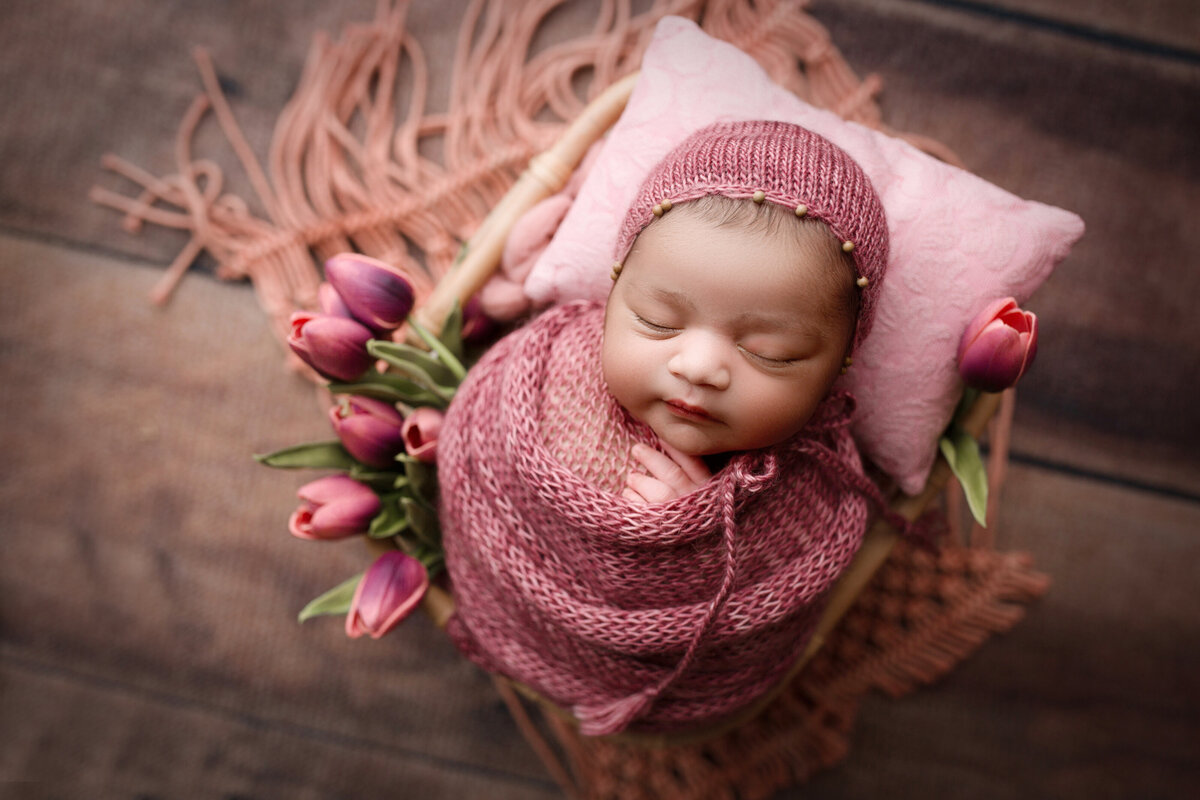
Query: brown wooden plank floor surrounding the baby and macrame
0 0 1200 800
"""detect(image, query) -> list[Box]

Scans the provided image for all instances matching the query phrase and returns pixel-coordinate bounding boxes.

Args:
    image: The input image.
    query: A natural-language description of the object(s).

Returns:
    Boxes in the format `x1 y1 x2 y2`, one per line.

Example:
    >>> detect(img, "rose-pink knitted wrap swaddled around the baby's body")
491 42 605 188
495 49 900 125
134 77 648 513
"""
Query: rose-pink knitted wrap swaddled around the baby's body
438 302 868 734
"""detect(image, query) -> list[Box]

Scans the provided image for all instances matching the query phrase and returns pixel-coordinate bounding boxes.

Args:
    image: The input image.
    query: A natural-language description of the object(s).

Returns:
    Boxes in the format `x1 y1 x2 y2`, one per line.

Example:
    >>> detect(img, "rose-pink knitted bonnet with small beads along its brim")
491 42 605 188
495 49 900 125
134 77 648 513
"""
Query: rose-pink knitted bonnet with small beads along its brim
614 120 888 350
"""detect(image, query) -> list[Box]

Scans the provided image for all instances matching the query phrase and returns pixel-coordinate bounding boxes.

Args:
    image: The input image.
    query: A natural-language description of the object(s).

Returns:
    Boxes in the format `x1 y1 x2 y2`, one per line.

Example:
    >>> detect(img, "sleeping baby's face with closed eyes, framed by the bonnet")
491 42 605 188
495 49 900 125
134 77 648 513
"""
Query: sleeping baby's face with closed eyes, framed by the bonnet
602 205 852 456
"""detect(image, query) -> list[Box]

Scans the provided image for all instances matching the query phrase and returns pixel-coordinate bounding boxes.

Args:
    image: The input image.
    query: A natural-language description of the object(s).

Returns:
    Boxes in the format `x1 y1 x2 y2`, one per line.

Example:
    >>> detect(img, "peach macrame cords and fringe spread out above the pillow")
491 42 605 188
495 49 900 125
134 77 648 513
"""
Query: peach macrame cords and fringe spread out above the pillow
91 0 955 362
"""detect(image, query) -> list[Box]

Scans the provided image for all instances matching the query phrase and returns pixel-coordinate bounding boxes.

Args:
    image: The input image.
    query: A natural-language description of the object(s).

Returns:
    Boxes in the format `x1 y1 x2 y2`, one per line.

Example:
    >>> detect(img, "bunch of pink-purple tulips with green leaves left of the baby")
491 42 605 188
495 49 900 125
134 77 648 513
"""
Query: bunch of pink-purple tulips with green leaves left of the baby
256 253 487 638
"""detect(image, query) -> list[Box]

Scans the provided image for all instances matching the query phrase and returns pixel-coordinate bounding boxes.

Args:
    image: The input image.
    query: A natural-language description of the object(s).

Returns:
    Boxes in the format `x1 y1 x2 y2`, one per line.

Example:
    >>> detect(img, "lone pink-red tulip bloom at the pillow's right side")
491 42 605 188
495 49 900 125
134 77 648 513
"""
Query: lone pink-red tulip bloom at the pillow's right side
959 297 1038 392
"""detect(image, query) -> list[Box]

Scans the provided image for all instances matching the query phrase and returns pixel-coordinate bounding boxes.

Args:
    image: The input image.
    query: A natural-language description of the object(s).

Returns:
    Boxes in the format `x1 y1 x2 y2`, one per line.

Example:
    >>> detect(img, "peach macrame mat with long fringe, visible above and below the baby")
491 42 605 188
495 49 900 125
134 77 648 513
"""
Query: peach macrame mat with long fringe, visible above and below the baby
91 0 1048 800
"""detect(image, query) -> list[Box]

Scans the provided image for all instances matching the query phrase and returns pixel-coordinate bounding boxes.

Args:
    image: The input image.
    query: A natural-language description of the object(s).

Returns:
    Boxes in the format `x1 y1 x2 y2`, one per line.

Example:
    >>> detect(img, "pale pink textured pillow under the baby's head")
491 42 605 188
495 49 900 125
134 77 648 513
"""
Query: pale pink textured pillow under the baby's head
524 17 1084 494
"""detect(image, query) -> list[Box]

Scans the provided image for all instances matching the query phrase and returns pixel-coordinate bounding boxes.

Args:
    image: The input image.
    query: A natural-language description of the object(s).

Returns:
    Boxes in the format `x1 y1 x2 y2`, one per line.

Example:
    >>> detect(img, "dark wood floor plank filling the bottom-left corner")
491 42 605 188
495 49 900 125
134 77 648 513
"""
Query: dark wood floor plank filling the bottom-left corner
0 651 562 800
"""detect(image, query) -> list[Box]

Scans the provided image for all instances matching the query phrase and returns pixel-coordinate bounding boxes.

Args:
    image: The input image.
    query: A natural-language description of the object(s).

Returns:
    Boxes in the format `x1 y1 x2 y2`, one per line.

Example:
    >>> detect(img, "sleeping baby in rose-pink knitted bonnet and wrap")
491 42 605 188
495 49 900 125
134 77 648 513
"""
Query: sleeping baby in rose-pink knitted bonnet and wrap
439 121 887 734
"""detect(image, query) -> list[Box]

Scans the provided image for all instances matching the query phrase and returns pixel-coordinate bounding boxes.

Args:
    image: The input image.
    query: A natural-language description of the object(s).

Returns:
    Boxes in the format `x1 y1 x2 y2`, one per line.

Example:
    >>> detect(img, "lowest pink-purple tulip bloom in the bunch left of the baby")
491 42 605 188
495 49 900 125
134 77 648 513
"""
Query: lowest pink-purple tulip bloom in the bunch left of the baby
346 551 430 639
